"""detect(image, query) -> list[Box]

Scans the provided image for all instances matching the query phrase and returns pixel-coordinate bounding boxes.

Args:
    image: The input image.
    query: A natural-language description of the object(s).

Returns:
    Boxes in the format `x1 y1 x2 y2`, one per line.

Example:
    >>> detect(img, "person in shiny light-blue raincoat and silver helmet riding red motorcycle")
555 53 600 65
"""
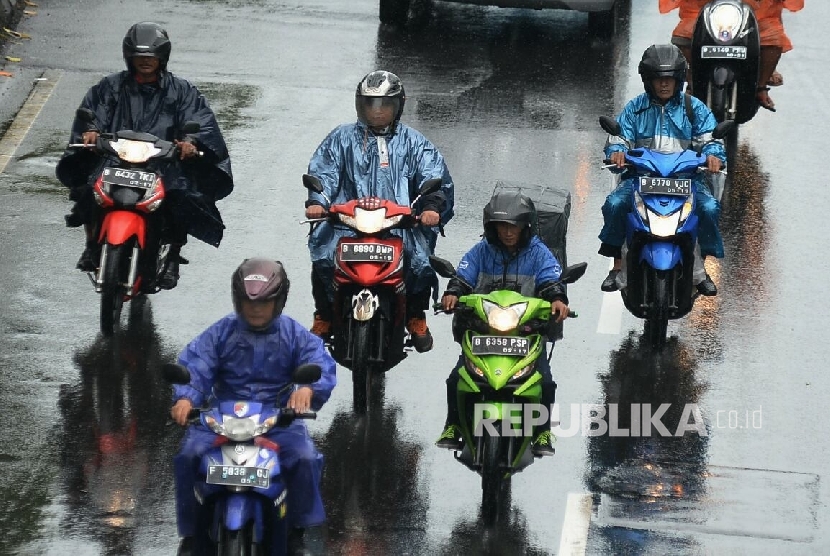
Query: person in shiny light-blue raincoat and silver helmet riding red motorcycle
305 70 454 352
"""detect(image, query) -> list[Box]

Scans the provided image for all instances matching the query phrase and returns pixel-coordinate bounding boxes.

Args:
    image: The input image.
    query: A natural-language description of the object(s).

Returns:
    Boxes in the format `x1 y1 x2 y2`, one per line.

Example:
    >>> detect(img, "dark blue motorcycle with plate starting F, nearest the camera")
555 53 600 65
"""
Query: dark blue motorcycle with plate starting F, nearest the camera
162 364 321 556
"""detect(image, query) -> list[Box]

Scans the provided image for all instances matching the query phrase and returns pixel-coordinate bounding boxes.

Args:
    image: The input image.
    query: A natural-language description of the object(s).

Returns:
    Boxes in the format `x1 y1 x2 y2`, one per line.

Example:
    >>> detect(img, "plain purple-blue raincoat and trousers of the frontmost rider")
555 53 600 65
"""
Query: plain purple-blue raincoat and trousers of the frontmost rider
173 314 337 537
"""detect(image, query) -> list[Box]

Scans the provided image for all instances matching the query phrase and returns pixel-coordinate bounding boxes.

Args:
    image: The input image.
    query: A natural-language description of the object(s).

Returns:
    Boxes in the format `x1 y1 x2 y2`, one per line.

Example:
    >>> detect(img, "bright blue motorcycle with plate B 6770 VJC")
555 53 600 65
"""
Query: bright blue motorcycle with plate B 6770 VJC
600 116 735 349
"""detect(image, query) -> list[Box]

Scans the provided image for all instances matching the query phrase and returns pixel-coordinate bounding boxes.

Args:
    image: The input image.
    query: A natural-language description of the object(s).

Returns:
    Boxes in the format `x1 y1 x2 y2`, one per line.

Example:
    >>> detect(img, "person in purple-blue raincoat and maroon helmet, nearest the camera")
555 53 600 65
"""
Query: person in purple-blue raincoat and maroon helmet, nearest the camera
170 258 337 554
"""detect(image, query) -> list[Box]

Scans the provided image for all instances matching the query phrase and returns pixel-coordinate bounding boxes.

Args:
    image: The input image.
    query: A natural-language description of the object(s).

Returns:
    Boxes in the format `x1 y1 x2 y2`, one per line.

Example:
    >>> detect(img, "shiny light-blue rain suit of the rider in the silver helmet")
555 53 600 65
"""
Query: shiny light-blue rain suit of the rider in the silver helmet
306 122 455 299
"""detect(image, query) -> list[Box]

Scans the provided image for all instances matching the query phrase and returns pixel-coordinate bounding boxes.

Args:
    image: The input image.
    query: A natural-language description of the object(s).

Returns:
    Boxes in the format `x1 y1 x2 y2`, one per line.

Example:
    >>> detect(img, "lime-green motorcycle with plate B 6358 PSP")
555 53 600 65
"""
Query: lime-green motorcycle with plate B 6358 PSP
430 256 587 521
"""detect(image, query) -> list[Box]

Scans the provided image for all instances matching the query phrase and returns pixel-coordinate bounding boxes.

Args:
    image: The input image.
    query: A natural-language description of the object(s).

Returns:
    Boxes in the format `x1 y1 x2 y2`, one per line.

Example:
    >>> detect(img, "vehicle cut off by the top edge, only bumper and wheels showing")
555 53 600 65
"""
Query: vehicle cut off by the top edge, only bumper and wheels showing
379 0 623 37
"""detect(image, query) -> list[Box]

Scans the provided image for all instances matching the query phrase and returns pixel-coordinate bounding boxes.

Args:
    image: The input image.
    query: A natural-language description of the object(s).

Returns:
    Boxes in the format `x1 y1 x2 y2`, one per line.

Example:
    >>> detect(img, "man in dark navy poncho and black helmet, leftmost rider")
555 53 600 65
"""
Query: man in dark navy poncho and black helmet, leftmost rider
56 21 233 289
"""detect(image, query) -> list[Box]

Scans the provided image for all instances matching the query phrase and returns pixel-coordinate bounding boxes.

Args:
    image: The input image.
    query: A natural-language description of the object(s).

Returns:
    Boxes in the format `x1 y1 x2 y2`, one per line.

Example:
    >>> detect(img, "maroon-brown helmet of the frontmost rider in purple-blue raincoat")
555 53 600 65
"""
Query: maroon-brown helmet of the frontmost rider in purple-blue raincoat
231 257 291 324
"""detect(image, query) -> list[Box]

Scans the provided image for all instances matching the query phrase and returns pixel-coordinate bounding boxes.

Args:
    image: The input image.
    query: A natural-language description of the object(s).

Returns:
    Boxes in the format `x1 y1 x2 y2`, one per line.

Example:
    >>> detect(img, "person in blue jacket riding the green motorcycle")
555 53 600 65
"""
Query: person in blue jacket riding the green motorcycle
435 191 568 456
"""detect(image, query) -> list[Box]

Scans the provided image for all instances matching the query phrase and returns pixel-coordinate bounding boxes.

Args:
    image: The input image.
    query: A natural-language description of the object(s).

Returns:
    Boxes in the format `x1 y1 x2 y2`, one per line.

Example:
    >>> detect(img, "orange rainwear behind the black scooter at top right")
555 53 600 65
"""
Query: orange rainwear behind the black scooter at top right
659 0 804 52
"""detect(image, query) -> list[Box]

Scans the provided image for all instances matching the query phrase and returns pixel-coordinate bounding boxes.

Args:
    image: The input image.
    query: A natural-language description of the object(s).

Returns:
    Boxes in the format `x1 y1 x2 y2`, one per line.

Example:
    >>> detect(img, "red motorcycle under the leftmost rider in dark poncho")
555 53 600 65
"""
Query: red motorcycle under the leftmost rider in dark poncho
69 108 202 336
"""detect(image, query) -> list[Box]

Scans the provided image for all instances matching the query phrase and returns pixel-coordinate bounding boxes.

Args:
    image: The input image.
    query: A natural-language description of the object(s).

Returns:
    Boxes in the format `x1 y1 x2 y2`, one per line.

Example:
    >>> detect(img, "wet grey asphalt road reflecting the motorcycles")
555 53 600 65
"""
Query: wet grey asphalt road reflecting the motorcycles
0 0 830 555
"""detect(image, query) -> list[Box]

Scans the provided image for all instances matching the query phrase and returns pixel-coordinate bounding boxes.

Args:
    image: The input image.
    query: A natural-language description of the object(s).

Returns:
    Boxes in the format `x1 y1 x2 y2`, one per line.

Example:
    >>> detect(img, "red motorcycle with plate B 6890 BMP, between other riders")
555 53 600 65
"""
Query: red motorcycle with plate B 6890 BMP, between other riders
303 174 441 413
